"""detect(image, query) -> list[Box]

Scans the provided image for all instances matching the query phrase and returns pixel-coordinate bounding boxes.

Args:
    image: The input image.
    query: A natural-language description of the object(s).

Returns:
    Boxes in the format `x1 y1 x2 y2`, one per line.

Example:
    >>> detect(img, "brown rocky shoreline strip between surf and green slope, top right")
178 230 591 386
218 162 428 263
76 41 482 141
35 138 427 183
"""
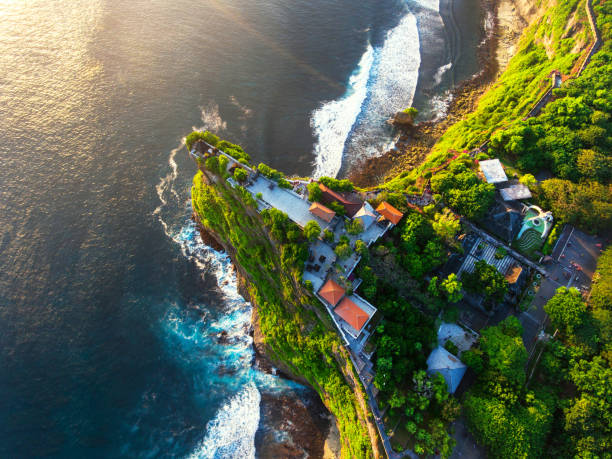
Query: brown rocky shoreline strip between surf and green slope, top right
348 0 539 187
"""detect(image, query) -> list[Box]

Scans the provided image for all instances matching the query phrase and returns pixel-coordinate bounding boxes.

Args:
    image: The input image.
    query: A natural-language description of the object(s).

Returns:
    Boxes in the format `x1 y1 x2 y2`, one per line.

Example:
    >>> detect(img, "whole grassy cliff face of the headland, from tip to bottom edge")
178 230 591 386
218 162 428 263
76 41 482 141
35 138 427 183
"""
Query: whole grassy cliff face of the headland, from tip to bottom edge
192 164 381 458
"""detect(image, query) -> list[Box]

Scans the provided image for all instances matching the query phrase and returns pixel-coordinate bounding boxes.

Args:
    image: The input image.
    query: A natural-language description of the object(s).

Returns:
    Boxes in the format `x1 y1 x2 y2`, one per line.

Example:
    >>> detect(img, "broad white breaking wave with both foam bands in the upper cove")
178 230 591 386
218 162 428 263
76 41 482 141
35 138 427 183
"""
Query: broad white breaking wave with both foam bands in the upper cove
311 5 420 177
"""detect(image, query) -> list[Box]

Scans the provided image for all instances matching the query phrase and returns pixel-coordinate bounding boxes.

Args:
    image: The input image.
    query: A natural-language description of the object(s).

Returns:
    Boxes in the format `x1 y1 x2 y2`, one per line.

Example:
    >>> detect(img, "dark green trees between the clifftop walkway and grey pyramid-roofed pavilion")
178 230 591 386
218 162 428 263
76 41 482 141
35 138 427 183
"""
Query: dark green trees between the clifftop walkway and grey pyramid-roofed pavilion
374 300 457 457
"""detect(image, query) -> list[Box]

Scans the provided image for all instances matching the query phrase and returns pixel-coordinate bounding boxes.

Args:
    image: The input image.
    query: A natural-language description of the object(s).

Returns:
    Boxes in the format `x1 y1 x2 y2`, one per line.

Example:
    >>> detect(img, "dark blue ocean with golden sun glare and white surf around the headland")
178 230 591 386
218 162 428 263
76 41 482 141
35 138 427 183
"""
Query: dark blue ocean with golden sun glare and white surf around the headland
0 0 482 458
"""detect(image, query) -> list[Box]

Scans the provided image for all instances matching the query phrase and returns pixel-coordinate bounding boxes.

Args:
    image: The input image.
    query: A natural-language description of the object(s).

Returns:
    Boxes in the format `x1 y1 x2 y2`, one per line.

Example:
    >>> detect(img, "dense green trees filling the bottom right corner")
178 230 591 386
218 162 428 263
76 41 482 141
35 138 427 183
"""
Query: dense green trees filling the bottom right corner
462 248 612 459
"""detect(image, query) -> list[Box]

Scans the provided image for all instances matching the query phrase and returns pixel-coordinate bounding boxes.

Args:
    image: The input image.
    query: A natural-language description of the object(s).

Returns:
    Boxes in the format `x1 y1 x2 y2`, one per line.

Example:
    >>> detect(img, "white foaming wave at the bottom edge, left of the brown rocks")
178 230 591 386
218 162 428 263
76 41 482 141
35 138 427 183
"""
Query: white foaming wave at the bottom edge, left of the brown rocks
189 384 261 459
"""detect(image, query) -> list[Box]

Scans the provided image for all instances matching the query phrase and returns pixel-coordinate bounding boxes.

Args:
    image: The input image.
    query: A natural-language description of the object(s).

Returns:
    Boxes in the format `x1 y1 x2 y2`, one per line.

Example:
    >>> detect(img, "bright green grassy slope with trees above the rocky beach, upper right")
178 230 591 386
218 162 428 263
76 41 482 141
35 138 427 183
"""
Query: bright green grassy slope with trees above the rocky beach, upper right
382 0 612 231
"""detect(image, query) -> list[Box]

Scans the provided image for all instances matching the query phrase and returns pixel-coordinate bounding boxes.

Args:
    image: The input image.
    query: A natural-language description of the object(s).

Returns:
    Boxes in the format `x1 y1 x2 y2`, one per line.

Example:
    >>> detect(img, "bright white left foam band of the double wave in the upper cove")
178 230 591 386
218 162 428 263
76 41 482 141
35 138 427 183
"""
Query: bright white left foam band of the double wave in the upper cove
310 43 374 177
